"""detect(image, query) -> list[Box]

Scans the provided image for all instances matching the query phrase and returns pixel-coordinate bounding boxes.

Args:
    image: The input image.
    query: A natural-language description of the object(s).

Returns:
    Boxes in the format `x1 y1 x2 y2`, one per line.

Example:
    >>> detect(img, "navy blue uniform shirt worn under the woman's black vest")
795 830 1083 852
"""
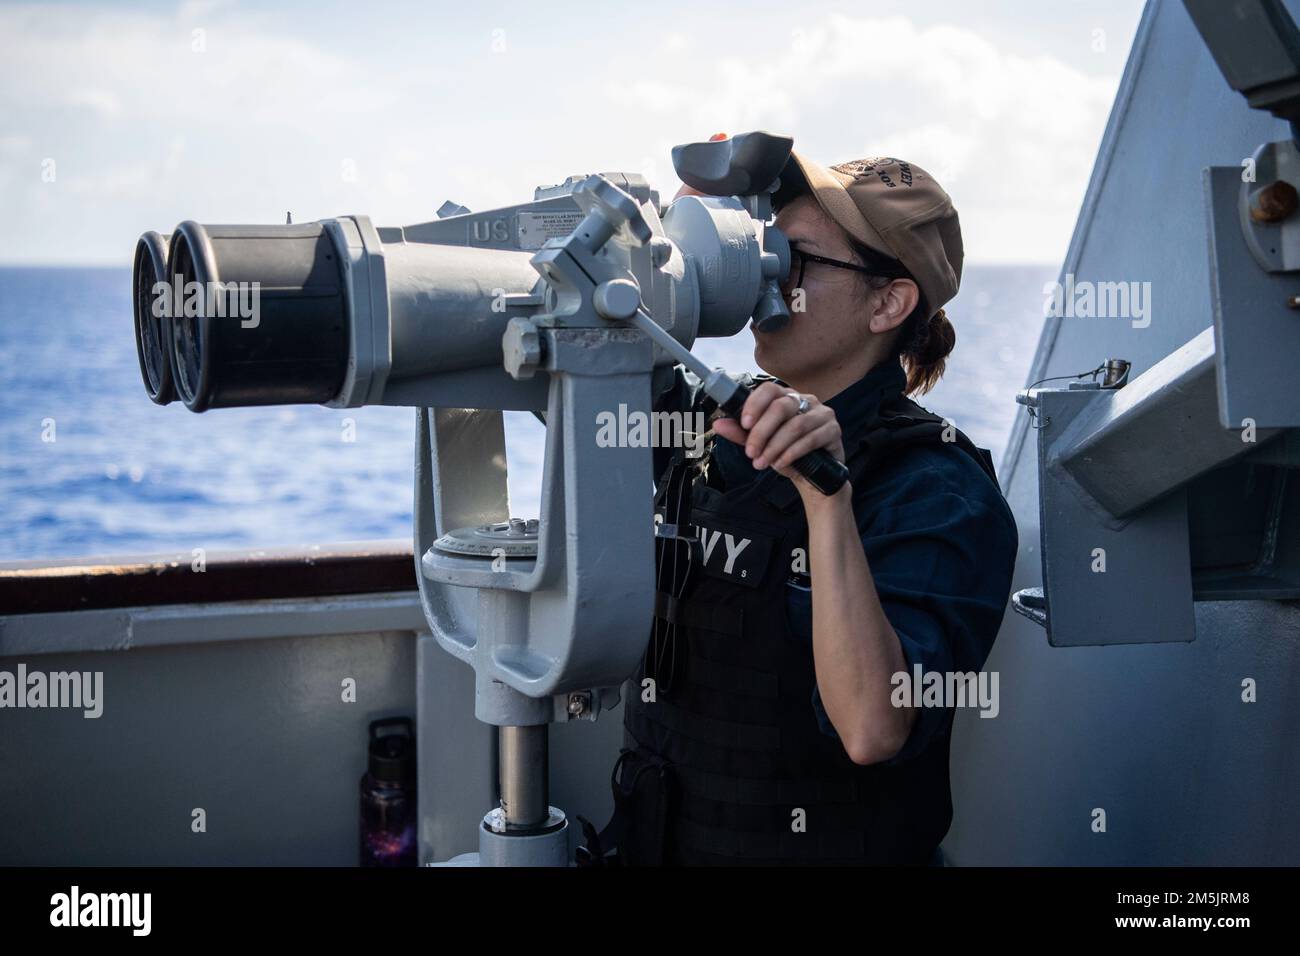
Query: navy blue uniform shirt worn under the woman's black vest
655 360 1018 763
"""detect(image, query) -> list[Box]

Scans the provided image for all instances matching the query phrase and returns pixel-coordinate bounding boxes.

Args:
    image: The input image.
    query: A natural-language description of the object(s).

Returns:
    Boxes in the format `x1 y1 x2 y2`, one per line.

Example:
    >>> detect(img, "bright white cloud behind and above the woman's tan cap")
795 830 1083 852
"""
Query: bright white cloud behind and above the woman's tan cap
610 14 1118 261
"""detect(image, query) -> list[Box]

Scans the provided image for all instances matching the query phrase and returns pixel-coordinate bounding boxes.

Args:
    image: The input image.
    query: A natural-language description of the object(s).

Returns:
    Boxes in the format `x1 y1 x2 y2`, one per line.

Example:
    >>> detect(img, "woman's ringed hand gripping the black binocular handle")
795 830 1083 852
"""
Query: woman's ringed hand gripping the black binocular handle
714 382 852 501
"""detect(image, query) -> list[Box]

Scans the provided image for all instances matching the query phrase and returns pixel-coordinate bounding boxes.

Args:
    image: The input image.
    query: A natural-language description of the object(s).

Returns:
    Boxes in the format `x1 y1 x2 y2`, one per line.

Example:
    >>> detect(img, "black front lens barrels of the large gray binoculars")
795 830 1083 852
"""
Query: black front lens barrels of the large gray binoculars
131 221 348 411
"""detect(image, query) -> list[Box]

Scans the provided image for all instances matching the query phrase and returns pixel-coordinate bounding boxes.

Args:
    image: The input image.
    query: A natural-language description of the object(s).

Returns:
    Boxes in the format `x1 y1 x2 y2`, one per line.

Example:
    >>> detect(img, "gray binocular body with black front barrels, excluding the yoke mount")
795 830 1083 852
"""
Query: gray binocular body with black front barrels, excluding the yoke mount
134 173 789 411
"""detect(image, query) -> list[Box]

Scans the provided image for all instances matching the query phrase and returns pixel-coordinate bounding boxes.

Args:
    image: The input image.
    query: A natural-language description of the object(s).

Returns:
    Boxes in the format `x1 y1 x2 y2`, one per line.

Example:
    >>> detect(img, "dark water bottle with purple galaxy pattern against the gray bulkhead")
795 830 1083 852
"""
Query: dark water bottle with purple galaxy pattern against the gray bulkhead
361 717 417 866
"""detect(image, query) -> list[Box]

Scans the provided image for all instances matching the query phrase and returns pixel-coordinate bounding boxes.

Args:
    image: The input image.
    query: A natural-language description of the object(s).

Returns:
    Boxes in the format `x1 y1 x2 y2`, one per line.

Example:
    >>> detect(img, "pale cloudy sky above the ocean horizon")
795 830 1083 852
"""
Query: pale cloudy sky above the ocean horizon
0 0 1141 267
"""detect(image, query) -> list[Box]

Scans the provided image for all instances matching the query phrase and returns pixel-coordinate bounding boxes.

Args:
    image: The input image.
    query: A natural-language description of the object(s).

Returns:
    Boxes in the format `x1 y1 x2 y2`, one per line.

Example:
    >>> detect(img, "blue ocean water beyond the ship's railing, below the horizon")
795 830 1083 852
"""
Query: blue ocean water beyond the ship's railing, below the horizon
0 265 1056 561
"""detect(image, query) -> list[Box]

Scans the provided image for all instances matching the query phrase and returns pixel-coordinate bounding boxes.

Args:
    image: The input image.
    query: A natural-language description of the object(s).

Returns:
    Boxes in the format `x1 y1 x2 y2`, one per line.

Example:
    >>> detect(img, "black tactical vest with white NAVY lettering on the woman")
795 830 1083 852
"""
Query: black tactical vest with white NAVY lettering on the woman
605 395 997 865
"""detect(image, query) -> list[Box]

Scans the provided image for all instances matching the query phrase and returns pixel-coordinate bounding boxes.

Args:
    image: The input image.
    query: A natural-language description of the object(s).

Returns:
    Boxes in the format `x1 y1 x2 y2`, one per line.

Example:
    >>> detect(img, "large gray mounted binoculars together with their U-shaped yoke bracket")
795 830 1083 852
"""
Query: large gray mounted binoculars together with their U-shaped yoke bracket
134 151 800 726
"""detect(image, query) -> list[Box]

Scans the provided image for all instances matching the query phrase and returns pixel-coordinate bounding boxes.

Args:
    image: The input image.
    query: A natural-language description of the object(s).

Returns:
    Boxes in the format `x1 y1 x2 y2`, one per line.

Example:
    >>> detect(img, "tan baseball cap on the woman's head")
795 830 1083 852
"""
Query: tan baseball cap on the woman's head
774 152 963 317
